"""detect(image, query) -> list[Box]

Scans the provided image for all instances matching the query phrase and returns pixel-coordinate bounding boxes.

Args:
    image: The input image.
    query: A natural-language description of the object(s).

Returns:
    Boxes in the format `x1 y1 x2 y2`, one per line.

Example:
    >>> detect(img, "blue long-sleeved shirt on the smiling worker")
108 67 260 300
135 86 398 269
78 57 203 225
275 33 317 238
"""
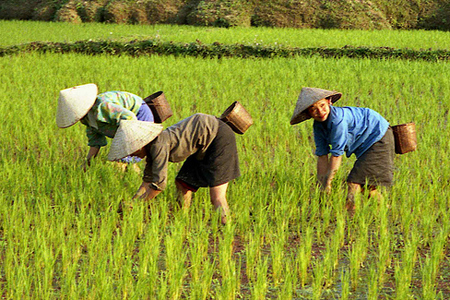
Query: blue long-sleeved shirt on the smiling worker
313 105 389 158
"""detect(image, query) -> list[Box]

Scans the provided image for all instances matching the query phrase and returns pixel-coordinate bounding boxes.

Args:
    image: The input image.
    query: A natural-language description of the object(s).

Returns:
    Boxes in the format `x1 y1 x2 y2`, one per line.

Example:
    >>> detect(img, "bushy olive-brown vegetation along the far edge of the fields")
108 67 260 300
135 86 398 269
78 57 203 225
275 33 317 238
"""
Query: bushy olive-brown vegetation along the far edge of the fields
0 0 450 30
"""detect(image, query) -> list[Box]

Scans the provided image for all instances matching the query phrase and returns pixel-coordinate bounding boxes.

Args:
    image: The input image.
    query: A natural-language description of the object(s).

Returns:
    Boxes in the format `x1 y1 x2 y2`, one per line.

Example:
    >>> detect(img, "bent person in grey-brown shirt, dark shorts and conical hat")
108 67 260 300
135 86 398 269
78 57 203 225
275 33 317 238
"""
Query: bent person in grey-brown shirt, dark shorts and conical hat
108 114 240 224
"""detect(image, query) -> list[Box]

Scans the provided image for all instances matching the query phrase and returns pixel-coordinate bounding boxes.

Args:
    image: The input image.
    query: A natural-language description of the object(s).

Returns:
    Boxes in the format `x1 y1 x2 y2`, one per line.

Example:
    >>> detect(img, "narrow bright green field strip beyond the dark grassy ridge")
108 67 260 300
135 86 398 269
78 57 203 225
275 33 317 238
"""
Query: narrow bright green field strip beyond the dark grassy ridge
0 20 450 50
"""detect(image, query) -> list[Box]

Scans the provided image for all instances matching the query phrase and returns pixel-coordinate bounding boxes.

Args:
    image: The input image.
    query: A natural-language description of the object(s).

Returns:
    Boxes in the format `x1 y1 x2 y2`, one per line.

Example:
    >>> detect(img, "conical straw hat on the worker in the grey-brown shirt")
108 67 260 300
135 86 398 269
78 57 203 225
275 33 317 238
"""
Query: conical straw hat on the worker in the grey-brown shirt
108 120 163 161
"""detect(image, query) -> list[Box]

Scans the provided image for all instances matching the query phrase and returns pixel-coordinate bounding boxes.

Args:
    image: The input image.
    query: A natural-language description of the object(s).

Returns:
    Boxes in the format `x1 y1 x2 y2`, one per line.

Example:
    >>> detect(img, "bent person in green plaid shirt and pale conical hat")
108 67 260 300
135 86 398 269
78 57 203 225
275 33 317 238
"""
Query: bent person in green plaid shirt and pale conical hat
56 83 154 170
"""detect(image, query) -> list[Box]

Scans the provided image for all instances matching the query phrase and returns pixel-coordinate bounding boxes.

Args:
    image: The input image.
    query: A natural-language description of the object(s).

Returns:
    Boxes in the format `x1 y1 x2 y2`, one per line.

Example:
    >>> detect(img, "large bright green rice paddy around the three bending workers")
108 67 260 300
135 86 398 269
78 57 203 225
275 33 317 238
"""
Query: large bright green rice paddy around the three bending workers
0 23 450 299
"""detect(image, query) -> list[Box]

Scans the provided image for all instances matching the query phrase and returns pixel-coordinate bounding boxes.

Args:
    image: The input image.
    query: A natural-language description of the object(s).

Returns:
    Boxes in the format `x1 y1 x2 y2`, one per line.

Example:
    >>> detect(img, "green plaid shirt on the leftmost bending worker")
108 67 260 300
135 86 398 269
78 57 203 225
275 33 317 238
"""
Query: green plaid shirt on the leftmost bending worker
80 91 143 147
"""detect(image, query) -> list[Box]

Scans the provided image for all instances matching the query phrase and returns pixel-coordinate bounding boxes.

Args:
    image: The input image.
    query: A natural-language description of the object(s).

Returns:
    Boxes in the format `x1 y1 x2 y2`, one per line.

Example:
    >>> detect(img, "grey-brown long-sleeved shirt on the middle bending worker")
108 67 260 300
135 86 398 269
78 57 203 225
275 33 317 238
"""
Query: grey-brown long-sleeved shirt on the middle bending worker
143 114 219 191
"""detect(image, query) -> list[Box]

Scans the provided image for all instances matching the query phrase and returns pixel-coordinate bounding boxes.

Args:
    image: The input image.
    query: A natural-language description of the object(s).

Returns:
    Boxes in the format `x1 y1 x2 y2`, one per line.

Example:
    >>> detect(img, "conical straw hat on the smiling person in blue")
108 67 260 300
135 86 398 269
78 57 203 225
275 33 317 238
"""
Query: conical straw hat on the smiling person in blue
291 87 342 125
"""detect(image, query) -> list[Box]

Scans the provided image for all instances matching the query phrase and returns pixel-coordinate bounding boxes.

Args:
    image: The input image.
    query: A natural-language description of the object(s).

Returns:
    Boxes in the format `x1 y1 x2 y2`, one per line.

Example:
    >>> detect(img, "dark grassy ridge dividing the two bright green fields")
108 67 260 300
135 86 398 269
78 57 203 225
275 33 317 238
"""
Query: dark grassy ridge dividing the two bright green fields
0 39 450 61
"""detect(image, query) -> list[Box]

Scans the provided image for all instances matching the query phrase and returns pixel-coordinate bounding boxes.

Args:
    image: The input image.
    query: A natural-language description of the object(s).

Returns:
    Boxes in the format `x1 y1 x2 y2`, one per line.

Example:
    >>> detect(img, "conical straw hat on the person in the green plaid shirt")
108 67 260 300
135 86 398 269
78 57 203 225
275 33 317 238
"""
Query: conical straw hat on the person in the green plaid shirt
56 83 98 128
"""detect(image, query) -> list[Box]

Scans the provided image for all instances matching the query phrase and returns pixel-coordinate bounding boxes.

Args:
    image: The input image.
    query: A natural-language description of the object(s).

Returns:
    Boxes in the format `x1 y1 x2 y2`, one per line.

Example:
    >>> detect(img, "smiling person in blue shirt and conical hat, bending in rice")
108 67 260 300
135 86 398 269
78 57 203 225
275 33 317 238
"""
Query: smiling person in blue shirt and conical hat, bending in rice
290 87 395 211
